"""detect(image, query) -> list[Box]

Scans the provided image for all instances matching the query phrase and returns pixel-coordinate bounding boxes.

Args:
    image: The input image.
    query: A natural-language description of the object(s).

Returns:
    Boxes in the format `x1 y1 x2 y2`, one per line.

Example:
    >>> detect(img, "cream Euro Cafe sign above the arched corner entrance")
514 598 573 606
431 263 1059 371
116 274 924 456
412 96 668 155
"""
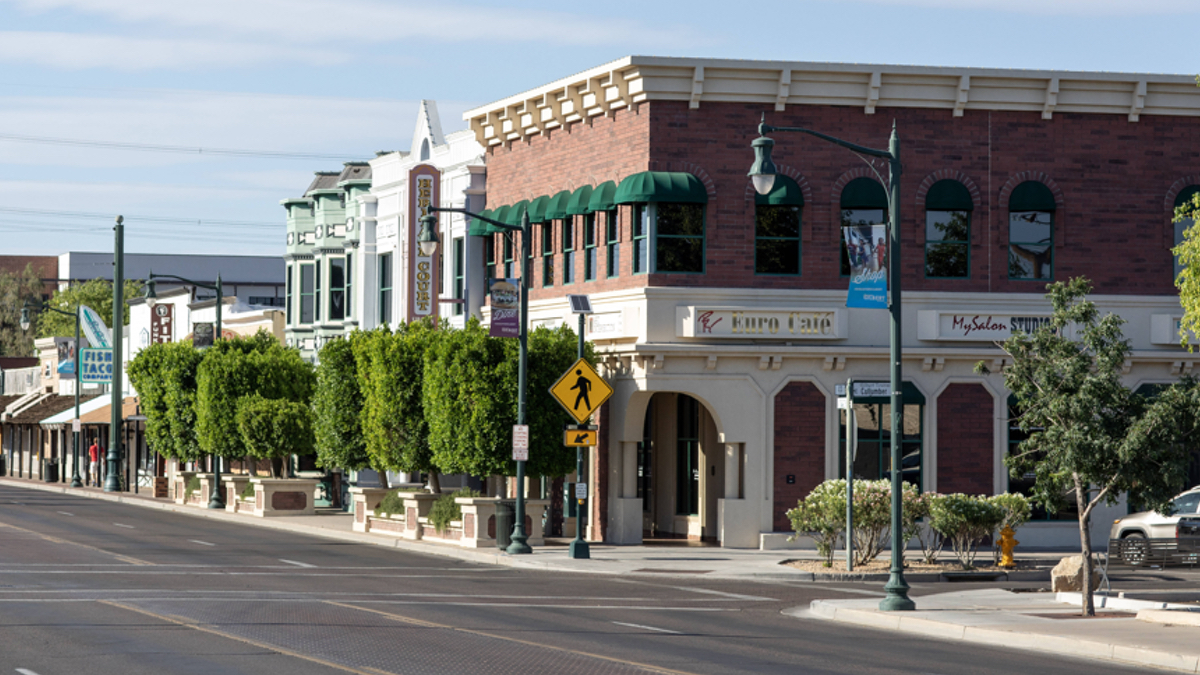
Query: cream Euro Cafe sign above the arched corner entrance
676 306 847 340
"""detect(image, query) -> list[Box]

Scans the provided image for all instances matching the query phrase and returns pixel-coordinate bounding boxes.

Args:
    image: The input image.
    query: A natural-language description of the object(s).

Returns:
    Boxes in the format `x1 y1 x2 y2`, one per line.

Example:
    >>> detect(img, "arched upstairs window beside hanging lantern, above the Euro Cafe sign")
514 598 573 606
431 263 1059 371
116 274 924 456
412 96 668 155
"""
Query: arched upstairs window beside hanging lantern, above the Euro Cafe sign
754 175 804 275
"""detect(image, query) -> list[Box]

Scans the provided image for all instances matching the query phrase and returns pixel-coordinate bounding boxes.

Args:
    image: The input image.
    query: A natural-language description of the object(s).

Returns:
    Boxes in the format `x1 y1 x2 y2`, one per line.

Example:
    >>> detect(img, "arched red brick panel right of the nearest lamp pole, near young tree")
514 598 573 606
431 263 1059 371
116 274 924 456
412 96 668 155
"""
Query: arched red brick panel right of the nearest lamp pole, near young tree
937 384 995 495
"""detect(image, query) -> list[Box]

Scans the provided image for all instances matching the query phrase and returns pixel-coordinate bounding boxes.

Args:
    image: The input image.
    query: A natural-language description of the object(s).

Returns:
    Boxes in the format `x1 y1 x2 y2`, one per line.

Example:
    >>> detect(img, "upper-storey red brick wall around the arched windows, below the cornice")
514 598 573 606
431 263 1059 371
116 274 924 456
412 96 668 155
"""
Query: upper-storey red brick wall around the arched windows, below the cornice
488 101 1200 298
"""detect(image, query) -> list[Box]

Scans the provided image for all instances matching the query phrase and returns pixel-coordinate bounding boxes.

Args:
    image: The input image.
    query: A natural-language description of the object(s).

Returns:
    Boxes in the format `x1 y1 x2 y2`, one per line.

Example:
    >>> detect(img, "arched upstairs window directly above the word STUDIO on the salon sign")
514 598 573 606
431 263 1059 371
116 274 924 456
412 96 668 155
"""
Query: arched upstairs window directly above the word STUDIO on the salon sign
1008 180 1055 281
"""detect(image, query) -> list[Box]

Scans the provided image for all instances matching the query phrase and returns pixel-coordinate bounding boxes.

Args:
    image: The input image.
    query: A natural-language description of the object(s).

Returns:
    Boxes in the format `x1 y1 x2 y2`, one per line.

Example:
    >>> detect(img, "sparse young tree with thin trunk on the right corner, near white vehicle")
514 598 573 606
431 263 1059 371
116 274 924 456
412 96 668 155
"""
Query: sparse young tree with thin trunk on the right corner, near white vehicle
976 279 1200 616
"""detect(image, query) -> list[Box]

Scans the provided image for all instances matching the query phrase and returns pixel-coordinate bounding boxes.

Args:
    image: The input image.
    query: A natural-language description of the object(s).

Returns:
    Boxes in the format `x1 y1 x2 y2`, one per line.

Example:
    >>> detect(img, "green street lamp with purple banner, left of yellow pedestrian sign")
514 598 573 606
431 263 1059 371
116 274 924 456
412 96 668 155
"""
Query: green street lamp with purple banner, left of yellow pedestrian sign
418 207 533 555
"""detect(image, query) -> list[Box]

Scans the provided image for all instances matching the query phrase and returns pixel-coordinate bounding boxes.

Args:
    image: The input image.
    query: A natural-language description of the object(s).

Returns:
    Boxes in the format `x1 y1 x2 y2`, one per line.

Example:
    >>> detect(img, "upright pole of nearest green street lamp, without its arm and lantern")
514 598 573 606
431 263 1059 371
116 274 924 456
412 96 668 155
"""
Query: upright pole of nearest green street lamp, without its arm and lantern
880 123 917 611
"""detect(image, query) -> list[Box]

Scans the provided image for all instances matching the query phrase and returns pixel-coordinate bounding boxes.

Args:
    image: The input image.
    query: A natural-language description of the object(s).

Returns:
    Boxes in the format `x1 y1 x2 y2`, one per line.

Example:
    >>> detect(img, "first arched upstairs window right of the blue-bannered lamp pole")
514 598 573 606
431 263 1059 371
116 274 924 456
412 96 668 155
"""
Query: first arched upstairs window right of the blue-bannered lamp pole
925 179 974 279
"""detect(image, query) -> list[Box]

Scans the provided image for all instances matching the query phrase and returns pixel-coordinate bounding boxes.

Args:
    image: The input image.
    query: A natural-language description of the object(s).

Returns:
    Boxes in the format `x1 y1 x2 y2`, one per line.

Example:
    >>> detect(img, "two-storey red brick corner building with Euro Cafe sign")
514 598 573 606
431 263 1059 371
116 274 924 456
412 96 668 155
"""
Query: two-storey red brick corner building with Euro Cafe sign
448 56 1200 548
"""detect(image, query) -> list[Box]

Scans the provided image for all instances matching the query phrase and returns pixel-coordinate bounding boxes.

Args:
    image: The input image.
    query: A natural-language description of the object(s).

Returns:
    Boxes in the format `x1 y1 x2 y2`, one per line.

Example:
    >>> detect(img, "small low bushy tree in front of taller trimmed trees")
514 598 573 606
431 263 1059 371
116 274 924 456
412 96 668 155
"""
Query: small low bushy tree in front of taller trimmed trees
236 394 314 477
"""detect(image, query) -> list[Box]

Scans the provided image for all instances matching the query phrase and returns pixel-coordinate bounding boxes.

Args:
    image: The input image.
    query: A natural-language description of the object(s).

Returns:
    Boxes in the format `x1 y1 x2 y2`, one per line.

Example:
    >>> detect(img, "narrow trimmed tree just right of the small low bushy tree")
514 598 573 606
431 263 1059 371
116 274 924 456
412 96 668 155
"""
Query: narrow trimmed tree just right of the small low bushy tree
312 338 371 471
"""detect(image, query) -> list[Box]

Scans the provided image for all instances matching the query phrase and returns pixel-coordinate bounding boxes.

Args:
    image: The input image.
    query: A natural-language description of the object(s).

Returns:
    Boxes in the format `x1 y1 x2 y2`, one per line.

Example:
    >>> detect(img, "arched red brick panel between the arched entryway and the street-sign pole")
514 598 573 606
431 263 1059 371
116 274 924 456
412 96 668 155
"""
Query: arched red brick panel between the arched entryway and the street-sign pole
773 382 826 532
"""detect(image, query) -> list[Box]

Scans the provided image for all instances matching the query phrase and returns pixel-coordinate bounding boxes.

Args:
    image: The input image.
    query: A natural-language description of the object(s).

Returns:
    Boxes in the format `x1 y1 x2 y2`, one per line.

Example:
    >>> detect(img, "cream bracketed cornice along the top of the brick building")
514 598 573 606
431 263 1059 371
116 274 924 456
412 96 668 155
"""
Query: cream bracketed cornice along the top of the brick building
463 56 1200 147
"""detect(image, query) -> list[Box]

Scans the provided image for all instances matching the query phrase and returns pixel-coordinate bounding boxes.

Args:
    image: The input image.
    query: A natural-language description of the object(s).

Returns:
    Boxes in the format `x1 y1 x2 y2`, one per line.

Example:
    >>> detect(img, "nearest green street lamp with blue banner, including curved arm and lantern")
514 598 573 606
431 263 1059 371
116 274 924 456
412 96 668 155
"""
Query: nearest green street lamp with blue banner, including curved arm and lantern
749 121 917 611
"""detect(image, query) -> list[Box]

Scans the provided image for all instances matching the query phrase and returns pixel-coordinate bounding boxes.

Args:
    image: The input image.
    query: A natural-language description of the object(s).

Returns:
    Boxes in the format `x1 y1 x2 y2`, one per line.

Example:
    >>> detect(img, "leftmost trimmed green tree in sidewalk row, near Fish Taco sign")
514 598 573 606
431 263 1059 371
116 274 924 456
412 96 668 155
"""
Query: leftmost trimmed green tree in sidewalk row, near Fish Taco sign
128 342 204 461
